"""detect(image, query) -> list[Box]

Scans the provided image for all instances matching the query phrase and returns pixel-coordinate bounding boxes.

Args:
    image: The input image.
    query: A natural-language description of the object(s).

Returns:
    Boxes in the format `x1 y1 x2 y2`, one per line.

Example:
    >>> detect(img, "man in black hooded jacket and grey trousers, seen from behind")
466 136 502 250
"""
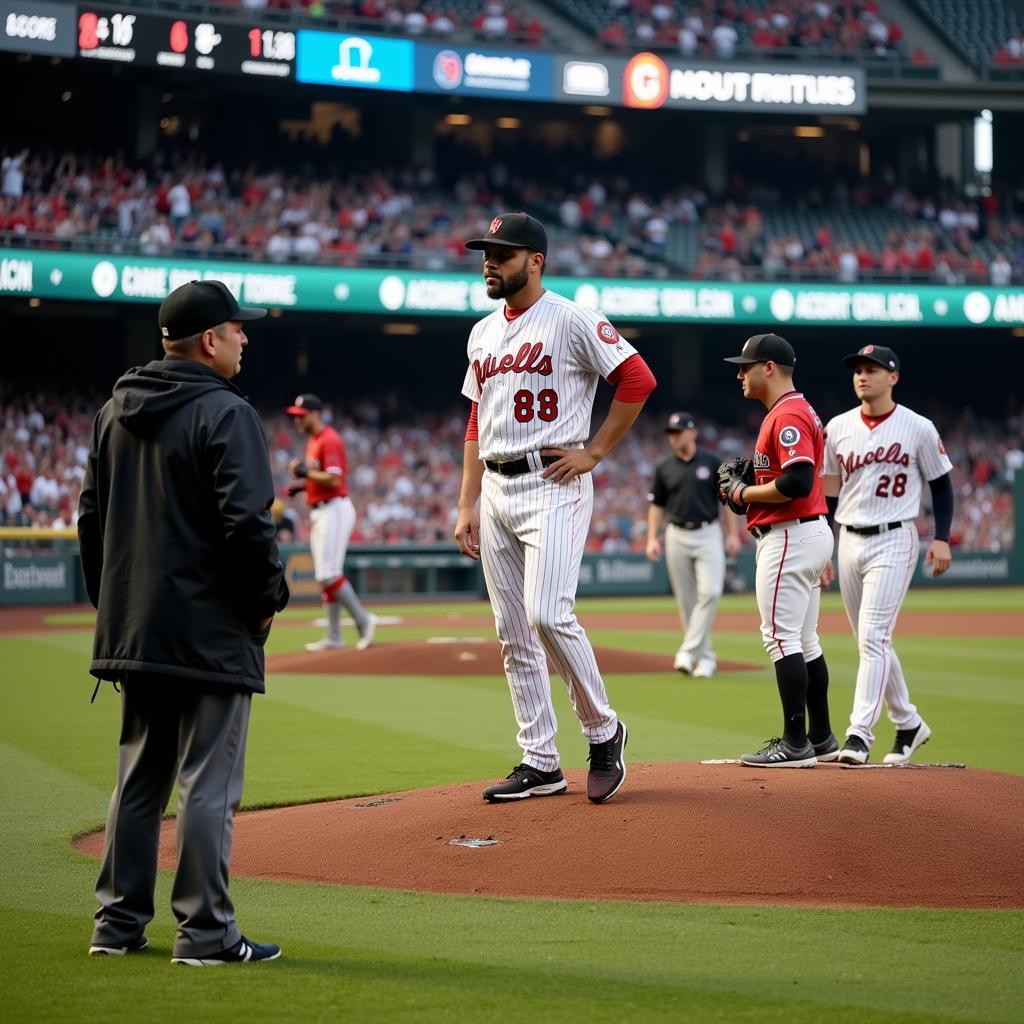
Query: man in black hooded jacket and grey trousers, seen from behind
78 281 288 966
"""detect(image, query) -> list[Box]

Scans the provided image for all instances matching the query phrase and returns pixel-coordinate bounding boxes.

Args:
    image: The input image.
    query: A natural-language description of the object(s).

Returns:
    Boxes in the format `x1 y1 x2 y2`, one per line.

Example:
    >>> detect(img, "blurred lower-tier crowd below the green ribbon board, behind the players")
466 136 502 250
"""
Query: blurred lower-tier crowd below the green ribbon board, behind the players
0 394 1024 553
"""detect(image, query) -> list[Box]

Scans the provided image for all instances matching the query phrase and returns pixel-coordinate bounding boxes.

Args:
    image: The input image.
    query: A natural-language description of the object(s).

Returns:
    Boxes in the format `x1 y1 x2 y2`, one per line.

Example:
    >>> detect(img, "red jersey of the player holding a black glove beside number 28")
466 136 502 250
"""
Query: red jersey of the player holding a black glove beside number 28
746 391 825 527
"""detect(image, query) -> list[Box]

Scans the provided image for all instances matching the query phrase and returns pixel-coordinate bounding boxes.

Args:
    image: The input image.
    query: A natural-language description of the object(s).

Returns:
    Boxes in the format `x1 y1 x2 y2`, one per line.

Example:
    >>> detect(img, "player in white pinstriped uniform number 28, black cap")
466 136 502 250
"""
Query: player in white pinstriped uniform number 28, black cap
824 345 953 764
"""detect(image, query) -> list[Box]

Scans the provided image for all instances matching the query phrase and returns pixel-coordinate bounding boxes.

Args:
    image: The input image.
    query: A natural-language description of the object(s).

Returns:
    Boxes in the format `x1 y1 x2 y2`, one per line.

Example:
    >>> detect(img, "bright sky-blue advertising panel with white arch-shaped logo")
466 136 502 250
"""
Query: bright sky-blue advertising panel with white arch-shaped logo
296 29 415 92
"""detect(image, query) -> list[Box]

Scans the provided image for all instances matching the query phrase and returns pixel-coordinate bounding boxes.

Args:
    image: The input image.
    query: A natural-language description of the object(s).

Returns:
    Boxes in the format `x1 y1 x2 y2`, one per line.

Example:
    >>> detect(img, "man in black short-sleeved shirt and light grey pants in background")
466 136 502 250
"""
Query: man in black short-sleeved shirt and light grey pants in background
647 413 740 679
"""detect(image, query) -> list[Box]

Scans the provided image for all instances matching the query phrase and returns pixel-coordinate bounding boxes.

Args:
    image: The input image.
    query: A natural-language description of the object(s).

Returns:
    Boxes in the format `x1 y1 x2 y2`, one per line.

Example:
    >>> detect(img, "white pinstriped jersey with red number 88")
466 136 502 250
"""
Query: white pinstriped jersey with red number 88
462 292 636 460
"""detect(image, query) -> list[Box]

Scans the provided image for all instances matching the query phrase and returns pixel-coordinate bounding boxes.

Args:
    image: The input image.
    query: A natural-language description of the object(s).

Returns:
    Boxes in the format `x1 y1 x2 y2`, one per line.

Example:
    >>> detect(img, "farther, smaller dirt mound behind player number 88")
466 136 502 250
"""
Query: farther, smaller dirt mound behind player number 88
266 637 763 676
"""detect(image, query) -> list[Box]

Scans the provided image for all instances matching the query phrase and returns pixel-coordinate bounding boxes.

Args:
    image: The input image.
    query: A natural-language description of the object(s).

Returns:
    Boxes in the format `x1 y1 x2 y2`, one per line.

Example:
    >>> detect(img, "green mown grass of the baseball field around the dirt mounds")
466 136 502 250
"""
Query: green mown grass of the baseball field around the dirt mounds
0 590 1024 1024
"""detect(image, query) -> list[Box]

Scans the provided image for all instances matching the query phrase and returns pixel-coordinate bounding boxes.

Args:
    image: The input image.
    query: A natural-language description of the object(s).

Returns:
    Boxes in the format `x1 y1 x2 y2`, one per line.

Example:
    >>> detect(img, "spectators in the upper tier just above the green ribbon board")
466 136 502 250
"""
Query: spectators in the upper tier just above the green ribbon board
0 150 1024 285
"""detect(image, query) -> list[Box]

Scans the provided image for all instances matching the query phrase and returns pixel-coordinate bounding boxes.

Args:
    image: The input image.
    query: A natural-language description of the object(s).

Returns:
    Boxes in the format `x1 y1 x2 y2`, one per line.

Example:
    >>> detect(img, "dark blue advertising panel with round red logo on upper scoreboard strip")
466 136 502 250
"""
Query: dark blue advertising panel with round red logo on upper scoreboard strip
416 43 555 100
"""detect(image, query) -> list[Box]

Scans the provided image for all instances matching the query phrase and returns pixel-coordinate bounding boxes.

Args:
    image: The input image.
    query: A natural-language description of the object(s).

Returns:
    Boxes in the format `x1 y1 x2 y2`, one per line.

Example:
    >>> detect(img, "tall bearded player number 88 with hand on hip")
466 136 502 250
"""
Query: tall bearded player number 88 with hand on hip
455 213 654 804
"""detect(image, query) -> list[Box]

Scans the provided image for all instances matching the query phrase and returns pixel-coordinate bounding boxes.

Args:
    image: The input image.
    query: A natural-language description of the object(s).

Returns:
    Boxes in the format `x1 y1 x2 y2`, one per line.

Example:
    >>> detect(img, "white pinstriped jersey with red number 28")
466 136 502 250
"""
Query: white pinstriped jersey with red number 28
824 406 953 526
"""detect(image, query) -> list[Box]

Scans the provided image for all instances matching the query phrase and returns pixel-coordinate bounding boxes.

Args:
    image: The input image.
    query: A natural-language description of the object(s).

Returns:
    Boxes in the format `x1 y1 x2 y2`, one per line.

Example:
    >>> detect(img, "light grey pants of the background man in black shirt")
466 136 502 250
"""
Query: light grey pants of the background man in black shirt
665 521 725 664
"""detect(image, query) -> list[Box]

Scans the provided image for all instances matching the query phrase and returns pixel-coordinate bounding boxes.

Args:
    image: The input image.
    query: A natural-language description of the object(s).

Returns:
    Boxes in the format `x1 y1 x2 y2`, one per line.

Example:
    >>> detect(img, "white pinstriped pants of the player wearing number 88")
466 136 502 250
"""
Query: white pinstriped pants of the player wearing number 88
480 459 618 771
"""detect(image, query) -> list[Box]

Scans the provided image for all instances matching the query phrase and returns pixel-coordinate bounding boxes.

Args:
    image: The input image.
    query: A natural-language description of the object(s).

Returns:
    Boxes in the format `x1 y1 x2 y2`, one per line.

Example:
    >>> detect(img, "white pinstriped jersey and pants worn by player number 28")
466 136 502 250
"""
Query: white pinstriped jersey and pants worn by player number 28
825 406 952 746
